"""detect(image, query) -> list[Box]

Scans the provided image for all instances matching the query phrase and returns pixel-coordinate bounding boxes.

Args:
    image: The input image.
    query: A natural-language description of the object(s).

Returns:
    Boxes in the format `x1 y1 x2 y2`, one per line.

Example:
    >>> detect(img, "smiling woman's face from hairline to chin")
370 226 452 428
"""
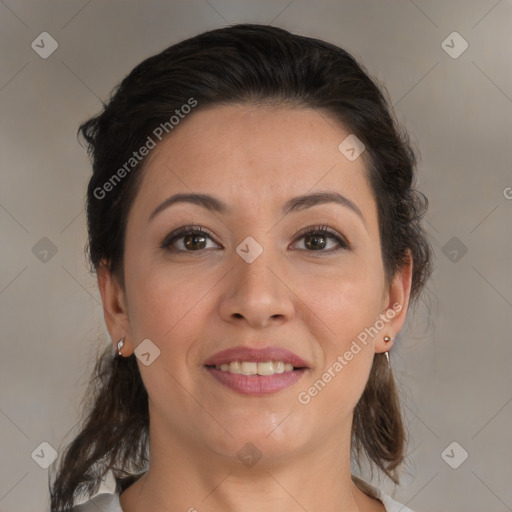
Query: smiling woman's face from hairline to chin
102 105 410 464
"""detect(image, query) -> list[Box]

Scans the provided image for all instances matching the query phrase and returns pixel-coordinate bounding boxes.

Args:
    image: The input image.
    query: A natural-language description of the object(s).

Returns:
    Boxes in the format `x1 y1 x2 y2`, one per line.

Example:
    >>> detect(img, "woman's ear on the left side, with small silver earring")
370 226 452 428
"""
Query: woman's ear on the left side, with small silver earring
96 260 133 356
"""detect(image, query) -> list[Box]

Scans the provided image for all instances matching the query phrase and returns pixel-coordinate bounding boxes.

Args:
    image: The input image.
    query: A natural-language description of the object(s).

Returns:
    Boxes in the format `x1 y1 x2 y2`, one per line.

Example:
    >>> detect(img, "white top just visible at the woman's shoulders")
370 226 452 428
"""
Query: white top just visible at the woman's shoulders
64 470 413 512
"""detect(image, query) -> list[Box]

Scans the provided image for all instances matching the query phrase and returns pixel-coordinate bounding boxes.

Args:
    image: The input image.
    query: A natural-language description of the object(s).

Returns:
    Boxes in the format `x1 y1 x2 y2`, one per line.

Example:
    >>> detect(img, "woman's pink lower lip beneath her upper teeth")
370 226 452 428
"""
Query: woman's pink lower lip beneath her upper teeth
205 366 306 395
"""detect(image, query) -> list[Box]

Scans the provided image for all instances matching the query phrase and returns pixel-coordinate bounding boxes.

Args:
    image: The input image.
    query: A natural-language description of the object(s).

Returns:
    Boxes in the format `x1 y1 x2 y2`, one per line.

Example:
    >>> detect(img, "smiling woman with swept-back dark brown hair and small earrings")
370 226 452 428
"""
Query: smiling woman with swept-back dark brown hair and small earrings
50 24 431 512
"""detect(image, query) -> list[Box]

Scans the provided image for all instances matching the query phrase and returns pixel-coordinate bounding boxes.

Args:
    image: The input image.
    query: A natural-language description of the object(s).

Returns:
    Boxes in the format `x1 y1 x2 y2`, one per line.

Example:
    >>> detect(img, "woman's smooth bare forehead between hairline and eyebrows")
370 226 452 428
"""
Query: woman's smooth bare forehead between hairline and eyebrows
128 104 375 225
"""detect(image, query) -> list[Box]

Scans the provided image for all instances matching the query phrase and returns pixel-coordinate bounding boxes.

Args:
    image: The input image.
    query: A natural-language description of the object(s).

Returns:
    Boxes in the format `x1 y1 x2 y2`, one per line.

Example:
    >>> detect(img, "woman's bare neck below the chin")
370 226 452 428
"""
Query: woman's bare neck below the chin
120 422 376 512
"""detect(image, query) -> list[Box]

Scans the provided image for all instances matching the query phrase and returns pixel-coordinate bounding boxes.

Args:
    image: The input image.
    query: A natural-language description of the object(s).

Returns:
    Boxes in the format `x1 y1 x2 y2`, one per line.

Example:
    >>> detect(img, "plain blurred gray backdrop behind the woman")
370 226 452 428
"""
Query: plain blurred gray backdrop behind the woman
0 0 512 512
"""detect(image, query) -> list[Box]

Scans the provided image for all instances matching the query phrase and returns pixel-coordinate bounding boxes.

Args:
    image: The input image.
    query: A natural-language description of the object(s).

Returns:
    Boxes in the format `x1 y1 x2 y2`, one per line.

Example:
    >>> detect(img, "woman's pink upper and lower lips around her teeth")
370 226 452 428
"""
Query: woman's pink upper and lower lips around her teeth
205 347 309 395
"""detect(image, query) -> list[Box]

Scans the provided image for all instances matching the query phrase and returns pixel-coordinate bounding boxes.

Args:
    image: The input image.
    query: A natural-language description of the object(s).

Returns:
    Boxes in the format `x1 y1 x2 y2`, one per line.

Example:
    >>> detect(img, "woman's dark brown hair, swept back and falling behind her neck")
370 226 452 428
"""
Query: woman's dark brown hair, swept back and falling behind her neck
50 24 432 512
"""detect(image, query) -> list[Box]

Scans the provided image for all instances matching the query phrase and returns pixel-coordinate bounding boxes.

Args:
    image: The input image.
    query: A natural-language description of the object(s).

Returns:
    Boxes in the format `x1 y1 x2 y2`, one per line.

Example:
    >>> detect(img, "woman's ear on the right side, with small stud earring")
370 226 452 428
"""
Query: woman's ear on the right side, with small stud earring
375 249 414 352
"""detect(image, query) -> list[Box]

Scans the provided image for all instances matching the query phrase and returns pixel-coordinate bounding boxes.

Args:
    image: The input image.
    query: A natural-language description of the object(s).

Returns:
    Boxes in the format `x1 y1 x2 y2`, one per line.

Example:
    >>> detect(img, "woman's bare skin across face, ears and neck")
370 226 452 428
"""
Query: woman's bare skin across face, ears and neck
98 105 412 512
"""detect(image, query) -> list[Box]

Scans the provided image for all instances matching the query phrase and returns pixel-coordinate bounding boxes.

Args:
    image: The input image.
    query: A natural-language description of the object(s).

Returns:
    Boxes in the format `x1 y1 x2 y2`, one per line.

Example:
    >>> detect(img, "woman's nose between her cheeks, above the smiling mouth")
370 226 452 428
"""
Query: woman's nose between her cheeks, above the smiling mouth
220 246 295 329
